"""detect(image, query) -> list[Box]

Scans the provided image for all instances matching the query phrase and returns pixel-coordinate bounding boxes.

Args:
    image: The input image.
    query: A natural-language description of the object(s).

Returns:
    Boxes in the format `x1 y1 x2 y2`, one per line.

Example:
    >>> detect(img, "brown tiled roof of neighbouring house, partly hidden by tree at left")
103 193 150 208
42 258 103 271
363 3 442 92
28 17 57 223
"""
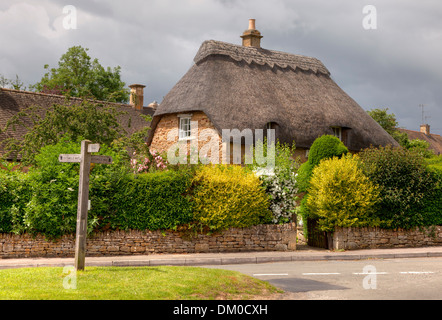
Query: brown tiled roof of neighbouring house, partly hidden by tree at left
0 88 154 156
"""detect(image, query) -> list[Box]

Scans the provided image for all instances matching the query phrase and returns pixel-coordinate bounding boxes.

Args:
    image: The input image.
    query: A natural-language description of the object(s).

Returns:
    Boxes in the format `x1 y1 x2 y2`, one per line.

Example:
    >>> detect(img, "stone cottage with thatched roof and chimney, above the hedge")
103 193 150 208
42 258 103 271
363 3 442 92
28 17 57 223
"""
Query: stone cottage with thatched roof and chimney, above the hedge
148 19 397 163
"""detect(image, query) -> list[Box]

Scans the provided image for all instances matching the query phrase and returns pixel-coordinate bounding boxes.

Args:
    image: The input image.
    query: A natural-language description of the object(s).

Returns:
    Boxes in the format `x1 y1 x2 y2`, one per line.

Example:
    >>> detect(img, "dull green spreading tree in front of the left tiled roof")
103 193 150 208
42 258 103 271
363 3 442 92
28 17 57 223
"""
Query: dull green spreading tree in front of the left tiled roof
4 100 150 164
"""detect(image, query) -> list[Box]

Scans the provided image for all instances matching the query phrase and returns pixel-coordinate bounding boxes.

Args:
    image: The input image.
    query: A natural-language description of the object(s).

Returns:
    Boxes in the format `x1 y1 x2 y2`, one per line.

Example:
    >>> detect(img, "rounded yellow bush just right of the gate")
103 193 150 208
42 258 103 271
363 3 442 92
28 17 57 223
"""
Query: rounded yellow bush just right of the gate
307 155 379 231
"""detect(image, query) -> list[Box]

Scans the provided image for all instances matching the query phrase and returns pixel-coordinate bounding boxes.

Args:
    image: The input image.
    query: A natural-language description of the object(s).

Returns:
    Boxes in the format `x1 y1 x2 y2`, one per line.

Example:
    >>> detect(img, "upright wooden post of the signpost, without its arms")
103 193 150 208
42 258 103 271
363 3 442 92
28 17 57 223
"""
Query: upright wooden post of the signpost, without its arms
75 140 91 270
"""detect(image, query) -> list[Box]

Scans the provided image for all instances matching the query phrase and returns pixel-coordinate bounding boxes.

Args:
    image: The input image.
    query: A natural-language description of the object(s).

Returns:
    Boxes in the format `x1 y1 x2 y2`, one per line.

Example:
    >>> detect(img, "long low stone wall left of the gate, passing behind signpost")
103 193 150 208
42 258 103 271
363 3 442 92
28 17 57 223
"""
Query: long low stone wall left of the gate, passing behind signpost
0 223 297 258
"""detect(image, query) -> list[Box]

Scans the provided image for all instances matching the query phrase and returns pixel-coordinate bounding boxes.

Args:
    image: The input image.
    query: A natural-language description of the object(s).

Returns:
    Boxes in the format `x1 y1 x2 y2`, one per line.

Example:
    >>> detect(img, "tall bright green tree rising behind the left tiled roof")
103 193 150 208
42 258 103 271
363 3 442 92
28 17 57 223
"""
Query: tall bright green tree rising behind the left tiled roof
31 46 129 102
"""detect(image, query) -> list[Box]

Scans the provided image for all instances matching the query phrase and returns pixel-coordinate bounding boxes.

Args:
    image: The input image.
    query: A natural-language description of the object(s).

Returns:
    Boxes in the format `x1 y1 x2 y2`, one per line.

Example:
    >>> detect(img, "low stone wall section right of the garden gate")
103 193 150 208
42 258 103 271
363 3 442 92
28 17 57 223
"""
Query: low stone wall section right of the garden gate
330 226 442 250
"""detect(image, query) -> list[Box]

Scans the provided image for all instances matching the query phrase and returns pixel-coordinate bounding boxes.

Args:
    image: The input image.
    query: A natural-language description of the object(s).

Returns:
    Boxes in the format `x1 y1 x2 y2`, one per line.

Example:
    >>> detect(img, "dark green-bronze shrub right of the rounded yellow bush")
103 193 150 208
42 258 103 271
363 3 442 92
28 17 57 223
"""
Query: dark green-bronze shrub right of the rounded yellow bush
360 146 441 228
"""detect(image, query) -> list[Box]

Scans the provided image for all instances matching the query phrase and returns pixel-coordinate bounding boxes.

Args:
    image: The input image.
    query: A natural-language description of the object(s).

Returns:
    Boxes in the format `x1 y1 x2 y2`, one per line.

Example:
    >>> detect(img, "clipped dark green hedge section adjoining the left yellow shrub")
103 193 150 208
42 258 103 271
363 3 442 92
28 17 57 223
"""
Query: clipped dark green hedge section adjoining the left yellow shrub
108 171 192 230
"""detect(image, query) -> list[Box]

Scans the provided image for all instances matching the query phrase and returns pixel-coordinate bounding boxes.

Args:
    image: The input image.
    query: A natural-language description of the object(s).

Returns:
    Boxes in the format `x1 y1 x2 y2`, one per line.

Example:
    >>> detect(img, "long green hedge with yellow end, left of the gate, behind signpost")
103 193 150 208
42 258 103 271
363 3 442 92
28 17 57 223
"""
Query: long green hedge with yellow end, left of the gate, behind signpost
0 140 271 238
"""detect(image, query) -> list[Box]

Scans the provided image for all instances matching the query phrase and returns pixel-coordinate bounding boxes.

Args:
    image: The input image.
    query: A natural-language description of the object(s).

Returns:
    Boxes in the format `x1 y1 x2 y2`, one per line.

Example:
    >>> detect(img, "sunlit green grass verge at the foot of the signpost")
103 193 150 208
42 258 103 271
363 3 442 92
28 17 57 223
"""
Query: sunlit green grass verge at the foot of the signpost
0 267 281 300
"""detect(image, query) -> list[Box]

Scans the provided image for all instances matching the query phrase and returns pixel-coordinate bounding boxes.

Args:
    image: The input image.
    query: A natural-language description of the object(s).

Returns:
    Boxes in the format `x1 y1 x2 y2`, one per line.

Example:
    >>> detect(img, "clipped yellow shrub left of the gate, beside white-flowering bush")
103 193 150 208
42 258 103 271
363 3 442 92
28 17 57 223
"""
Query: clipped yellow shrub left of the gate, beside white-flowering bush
193 165 271 230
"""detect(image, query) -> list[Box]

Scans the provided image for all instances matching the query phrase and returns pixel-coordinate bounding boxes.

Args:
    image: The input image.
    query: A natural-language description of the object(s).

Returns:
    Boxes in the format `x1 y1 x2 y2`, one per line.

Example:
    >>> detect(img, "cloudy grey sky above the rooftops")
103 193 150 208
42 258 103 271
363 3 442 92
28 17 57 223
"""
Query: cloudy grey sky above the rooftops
0 0 442 134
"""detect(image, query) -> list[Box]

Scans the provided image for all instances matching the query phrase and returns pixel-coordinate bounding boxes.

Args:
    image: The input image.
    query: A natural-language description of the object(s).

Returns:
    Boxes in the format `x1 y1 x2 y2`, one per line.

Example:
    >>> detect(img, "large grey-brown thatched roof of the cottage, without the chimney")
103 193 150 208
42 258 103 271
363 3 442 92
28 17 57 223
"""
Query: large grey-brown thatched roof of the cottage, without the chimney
149 40 397 151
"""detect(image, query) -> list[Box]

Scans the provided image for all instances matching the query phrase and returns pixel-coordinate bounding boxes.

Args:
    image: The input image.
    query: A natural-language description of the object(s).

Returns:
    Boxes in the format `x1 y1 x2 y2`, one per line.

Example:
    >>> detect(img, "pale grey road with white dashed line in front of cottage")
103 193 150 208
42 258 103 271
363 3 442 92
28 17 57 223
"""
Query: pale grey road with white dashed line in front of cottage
206 258 442 300
